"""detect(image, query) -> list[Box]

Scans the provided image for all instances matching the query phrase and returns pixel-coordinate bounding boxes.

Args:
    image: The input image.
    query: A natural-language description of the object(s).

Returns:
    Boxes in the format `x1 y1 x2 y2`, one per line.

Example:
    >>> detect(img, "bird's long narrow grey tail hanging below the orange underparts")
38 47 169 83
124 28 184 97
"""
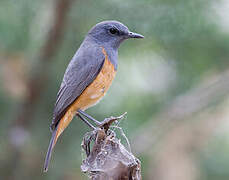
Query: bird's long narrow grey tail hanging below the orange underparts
44 126 58 172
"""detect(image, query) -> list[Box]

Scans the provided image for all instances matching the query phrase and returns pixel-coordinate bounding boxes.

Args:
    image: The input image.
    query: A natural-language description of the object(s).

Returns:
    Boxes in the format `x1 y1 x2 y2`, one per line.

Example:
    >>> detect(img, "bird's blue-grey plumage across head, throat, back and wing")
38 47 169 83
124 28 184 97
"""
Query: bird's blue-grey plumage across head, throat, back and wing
51 21 142 130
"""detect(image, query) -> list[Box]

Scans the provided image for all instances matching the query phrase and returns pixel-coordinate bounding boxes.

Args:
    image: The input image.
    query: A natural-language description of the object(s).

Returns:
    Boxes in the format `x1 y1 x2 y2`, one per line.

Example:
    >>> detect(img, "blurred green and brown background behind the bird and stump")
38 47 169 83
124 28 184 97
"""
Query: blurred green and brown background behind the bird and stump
0 0 229 180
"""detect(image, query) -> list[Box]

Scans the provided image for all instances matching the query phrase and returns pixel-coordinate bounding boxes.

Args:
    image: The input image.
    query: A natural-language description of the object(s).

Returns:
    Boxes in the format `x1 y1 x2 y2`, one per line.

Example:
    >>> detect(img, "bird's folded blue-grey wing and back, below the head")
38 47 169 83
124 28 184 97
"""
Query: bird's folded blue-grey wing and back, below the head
51 44 105 130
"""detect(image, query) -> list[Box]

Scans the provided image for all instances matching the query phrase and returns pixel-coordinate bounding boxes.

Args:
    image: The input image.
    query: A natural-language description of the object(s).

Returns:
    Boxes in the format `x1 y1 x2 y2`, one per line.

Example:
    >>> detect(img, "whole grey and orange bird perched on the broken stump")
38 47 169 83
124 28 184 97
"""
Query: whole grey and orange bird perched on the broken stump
44 20 144 172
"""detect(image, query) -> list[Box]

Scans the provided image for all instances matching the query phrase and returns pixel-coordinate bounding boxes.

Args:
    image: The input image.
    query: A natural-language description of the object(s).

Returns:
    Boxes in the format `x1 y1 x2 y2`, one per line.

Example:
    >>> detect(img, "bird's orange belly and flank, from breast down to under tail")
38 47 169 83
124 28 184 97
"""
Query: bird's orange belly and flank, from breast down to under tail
55 49 116 142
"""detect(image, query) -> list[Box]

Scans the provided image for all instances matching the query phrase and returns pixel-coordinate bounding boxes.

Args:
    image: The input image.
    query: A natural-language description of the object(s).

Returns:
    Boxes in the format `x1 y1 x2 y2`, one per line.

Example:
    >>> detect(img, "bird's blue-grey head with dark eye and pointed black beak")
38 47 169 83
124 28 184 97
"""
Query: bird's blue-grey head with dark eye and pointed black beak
88 21 144 49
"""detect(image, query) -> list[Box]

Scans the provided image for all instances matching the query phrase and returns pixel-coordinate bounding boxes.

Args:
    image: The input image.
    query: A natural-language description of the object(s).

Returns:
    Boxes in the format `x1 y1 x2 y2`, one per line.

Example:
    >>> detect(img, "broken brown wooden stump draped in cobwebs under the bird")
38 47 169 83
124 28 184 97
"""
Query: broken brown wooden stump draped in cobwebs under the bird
81 113 141 180
